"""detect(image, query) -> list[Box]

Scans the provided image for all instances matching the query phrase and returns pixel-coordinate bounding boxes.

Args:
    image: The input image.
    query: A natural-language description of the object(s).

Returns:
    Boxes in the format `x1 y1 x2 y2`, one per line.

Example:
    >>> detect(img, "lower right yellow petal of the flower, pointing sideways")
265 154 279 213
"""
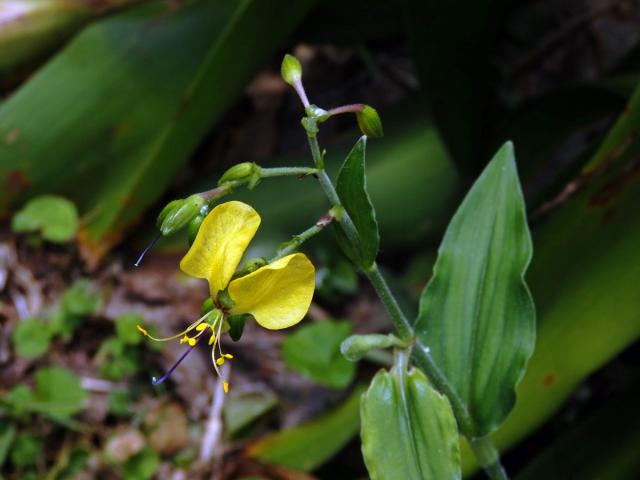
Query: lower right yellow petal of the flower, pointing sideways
229 253 315 330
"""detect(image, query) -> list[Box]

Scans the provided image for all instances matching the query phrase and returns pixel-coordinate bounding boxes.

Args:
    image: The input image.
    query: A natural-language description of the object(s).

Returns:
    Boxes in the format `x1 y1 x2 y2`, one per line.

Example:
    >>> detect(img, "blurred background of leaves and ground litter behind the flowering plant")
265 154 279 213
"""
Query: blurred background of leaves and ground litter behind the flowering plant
0 0 640 479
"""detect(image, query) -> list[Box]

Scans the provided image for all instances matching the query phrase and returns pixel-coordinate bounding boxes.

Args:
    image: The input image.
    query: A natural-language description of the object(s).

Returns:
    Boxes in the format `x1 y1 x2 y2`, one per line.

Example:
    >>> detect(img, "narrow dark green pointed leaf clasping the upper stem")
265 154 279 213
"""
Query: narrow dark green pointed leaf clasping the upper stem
336 136 380 269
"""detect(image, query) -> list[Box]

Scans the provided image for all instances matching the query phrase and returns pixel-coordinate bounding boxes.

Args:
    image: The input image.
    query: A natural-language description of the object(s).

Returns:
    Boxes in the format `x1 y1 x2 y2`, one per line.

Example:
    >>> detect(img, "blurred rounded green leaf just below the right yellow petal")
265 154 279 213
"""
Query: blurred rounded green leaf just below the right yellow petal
282 320 356 388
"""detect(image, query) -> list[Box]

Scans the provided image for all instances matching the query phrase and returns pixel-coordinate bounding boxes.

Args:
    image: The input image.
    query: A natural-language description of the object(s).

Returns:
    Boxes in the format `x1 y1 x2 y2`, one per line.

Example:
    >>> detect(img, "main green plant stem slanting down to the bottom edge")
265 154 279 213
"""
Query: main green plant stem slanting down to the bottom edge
307 125 508 480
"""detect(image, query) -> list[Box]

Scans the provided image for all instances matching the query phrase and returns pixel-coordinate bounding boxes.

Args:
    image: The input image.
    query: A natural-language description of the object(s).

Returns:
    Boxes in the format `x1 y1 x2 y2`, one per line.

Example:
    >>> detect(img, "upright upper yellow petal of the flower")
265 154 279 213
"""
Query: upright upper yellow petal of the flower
180 201 260 295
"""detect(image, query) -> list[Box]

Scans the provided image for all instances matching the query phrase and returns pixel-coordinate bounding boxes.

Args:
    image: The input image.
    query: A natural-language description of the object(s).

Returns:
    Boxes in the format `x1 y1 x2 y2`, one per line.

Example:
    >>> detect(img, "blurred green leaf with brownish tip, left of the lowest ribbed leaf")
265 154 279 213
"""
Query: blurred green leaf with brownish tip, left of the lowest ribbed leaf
248 388 363 472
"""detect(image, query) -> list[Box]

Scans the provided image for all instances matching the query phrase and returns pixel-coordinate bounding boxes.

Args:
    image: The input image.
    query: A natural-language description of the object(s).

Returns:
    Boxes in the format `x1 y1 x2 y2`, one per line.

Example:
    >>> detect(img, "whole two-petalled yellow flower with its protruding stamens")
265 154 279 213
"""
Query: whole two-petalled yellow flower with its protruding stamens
138 201 315 391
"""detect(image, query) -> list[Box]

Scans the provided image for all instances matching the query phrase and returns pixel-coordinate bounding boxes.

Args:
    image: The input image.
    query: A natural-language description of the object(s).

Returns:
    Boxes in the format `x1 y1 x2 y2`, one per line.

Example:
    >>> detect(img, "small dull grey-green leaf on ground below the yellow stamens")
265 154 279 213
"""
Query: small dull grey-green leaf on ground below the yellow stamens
222 390 278 437
